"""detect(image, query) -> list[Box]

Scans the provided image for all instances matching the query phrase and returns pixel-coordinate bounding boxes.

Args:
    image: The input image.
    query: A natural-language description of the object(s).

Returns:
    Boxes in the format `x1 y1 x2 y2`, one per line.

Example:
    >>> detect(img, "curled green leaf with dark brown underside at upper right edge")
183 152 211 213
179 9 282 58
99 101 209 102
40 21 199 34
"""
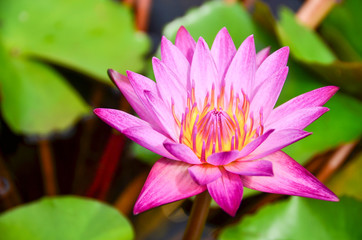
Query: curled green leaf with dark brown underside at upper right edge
277 8 362 99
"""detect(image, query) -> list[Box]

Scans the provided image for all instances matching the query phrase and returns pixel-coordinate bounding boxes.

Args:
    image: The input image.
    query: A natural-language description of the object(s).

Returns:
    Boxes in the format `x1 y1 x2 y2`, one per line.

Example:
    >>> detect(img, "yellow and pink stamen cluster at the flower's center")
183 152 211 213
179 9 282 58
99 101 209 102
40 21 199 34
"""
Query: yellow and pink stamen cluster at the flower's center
174 87 263 162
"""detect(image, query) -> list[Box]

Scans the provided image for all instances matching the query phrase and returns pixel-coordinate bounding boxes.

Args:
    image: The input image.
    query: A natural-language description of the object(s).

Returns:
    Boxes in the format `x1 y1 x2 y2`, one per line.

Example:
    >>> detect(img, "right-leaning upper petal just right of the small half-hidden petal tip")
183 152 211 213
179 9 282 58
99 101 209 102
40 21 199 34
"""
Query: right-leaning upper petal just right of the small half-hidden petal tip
255 47 289 88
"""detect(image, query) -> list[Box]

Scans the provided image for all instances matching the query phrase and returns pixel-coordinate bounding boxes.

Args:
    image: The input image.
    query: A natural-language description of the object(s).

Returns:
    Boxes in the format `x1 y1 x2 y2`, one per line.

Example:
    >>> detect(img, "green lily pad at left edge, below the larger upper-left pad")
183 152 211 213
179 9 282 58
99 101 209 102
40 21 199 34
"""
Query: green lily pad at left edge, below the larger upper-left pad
0 43 89 135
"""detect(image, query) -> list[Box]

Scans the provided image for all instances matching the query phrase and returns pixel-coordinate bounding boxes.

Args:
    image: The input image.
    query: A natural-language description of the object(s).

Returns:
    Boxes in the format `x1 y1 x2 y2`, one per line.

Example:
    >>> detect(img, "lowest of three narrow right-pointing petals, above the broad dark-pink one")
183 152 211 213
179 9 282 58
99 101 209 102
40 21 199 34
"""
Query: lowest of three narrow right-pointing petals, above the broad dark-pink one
244 129 311 160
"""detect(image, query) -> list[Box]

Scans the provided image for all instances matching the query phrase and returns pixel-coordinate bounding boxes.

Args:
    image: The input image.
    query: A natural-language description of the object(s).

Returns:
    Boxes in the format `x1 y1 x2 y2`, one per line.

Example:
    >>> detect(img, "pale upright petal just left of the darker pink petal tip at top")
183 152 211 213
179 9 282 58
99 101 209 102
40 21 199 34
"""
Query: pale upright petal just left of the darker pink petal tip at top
160 37 190 89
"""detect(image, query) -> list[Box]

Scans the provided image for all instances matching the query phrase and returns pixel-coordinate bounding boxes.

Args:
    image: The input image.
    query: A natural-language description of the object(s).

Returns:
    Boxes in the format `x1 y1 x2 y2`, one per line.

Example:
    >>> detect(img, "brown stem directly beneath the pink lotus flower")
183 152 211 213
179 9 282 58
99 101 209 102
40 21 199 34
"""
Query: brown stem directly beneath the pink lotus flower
183 191 211 240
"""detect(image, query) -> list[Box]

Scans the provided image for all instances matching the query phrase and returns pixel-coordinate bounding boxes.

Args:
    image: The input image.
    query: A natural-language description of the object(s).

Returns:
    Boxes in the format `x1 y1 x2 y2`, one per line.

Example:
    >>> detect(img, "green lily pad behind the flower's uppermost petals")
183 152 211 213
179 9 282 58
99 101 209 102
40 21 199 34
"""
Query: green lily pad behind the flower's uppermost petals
163 1 276 50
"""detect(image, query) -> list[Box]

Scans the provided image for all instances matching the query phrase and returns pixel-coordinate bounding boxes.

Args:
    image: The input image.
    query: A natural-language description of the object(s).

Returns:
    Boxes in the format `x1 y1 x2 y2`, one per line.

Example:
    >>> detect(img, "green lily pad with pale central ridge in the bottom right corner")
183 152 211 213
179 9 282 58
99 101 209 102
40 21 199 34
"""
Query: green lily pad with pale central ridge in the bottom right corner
220 197 362 240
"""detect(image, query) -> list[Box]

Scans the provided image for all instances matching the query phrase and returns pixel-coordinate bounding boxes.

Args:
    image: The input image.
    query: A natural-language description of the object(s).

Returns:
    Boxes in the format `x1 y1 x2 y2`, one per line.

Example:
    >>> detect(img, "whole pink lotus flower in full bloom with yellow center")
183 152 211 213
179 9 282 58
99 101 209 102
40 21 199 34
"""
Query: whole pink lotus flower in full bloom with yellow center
94 27 338 215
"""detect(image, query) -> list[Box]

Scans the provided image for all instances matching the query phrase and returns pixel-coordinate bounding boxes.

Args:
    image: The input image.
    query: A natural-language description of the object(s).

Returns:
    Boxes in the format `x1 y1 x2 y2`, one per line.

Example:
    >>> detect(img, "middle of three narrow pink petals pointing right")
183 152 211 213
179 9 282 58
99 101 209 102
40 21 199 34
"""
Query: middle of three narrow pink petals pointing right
265 107 329 130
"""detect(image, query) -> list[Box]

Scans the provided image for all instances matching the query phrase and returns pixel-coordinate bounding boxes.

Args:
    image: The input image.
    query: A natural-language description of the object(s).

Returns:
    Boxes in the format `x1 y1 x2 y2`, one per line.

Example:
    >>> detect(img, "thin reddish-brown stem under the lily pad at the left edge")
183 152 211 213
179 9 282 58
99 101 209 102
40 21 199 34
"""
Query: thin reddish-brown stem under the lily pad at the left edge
39 139 57 196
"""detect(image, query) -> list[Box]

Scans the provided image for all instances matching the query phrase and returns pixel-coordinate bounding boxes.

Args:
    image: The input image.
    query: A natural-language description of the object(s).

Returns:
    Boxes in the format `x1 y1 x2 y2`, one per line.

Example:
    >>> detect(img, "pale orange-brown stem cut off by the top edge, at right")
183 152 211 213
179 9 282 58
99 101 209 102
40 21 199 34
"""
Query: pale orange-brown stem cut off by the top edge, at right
296 0 339 29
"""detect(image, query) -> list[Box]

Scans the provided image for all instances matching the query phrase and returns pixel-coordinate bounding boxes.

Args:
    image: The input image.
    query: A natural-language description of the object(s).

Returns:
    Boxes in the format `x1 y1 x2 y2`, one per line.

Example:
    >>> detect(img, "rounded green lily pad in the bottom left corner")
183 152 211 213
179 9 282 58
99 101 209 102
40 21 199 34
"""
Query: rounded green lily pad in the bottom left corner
0 196 133 240
